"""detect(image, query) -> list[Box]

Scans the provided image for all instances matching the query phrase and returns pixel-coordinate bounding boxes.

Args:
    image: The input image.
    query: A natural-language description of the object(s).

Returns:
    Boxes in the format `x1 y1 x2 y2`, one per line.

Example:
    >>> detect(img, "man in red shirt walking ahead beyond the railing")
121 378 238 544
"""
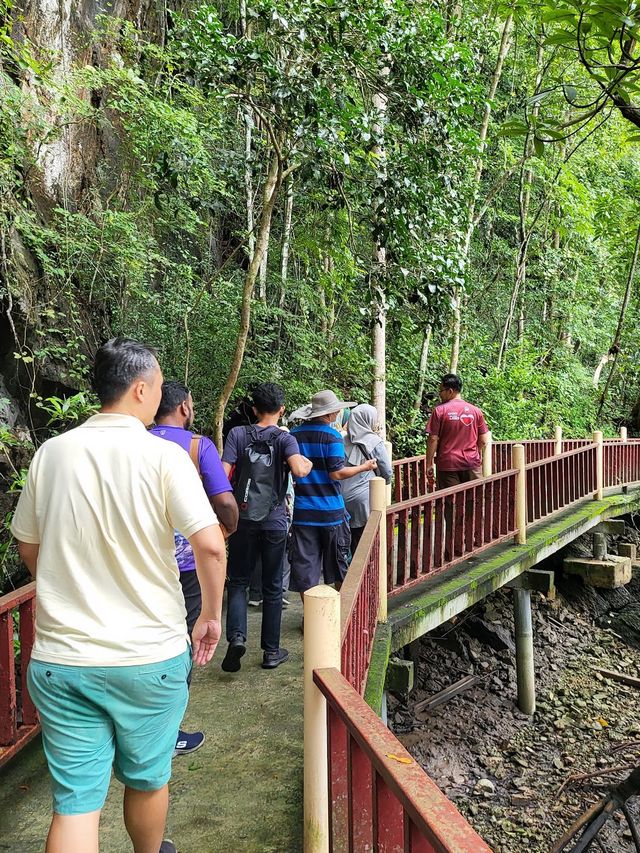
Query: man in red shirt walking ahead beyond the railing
427 373 489 489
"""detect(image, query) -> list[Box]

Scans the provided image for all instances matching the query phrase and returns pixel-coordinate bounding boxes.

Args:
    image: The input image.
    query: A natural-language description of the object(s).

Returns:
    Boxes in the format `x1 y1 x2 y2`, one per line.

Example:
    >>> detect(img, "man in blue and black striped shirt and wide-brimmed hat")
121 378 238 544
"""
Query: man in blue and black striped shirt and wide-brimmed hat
289 391 376 595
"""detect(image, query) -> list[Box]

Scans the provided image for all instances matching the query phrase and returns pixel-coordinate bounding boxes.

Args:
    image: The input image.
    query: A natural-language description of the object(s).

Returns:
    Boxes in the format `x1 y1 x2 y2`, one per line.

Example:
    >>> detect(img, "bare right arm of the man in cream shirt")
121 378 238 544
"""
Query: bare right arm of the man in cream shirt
189 524 227 666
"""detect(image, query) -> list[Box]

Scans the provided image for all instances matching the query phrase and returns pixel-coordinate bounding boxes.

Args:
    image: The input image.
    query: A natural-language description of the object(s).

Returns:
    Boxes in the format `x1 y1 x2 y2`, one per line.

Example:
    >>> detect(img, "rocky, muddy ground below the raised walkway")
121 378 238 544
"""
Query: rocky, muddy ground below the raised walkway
389 532 640 853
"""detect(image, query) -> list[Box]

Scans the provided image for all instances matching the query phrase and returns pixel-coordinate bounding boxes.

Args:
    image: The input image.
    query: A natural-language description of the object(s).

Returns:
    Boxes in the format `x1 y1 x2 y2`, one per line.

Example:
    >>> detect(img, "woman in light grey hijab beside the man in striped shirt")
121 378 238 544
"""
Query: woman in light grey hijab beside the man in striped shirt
342 405 392 554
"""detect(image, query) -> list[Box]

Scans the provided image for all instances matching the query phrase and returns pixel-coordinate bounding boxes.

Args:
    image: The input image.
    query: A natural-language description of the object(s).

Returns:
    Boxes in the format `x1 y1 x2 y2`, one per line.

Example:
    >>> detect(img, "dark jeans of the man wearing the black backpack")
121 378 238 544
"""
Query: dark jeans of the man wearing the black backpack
227 528 287 652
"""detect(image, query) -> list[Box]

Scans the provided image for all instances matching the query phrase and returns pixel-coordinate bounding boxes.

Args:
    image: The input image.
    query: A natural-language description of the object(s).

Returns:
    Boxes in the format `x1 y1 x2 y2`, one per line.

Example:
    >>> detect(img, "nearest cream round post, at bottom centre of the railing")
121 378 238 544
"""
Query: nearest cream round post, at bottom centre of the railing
303 585 340 853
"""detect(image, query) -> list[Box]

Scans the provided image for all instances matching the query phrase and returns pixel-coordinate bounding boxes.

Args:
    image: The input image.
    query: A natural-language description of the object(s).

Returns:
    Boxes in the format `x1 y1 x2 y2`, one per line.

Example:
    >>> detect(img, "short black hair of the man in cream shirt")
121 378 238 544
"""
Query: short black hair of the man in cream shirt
93 338 157 406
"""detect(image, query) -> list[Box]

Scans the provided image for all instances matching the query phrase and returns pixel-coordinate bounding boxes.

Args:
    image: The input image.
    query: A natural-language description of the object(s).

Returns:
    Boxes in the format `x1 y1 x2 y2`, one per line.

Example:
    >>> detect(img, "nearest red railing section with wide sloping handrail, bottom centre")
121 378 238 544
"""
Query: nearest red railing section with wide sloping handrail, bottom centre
313 669 491 853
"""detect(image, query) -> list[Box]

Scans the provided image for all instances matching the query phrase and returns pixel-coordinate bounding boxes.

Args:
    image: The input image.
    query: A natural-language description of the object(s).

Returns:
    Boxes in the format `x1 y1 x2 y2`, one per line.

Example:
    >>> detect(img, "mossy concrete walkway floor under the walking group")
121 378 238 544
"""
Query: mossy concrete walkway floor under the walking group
0 593 302 853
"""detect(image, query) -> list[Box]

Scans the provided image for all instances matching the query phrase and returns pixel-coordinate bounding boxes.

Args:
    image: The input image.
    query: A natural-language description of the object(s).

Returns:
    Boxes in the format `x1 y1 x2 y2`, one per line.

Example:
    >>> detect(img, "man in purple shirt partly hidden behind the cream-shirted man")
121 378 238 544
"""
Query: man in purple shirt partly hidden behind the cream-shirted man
151 381 238 755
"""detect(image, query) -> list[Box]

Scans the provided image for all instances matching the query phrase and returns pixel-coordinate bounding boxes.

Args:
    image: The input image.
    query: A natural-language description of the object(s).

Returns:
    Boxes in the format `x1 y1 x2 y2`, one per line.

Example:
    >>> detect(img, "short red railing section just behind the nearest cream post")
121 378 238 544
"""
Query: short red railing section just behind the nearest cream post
340 510 382 695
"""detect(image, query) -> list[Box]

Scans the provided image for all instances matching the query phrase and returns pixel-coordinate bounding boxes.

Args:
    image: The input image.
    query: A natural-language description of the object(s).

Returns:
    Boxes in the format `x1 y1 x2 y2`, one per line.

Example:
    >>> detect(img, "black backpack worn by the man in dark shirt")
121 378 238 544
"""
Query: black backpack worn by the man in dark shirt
233 426 287 521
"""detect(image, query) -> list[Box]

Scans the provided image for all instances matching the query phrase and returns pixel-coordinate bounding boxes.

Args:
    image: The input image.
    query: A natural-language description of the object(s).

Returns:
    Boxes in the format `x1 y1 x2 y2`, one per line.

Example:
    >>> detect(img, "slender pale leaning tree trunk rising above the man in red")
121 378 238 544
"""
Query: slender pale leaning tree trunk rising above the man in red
449 15 513 373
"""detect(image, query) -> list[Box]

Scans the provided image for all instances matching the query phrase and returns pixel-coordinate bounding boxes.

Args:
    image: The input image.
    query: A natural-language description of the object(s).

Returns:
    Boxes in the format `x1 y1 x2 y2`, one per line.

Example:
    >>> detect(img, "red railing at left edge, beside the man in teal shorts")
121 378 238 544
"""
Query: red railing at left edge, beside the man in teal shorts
0 583 40 767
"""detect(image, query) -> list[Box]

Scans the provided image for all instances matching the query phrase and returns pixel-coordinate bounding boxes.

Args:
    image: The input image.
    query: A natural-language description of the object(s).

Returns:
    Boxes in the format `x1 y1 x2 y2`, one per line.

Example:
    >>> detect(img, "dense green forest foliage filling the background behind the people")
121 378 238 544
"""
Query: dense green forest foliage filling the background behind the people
0 0 640 486
